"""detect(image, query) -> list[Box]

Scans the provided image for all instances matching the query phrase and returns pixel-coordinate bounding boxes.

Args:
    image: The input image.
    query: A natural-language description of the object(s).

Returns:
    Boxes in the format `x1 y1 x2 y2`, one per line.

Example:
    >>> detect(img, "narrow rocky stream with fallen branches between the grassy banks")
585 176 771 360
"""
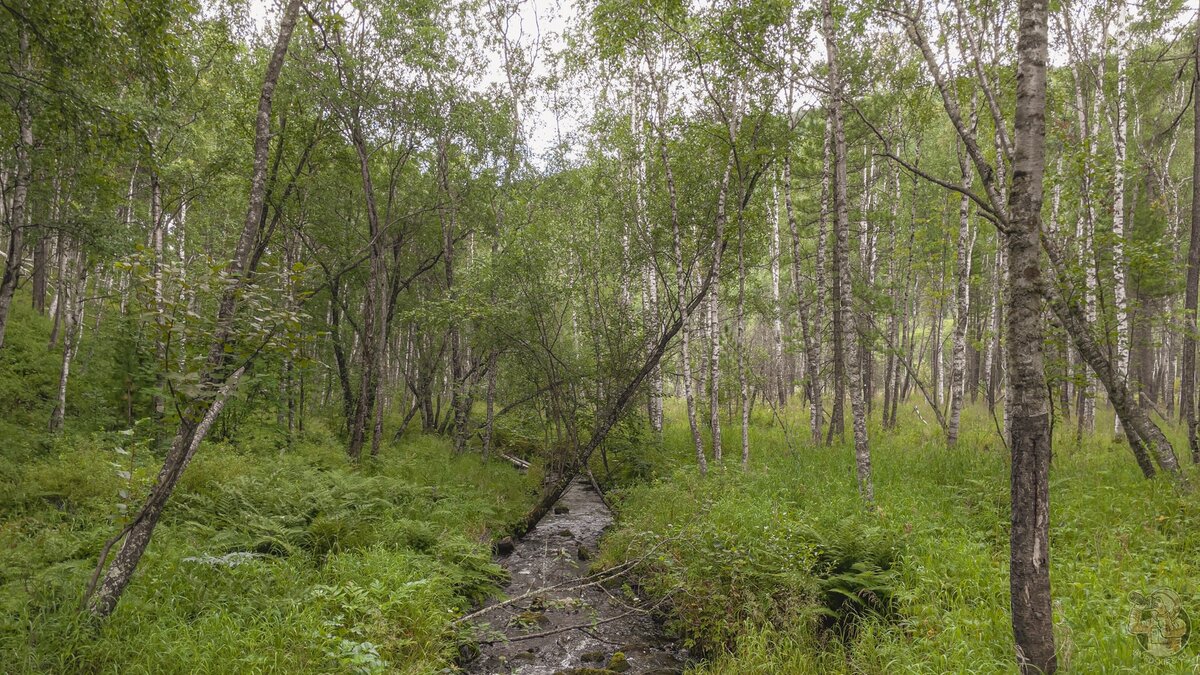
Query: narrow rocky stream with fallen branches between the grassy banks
463 478 686 675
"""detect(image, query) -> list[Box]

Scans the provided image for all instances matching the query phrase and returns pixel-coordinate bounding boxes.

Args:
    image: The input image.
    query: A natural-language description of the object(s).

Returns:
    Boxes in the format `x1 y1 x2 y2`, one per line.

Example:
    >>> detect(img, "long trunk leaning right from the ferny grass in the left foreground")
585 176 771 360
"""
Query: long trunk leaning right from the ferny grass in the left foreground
85 0 300 619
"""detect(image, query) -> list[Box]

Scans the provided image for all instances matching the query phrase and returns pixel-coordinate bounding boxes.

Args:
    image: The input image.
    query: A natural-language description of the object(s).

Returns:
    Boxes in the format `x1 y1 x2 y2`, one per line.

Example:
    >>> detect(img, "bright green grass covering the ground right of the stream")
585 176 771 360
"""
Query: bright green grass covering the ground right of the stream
601 398 1200 674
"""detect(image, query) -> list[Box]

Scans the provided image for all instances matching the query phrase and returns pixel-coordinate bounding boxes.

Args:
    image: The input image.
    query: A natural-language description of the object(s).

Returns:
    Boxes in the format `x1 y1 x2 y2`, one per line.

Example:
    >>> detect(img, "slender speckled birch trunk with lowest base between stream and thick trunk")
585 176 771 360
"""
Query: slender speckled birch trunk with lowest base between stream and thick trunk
822 0 875 506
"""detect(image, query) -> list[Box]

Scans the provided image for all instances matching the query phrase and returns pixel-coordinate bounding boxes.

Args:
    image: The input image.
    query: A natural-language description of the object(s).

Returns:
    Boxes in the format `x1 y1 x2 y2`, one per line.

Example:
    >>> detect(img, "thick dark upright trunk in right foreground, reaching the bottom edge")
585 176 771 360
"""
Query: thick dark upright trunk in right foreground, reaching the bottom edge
1007 0 1058 674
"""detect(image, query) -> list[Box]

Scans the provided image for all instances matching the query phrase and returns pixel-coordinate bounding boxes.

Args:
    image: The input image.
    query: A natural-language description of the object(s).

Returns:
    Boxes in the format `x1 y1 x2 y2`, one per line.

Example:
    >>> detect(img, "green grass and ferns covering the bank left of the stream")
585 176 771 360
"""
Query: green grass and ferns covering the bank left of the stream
0 422 534 673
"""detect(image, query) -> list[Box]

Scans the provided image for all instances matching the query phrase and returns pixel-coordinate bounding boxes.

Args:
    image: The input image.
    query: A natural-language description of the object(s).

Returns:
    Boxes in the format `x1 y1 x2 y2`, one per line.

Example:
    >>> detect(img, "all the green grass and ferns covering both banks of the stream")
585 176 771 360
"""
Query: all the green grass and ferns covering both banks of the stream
0 291 1200 674
